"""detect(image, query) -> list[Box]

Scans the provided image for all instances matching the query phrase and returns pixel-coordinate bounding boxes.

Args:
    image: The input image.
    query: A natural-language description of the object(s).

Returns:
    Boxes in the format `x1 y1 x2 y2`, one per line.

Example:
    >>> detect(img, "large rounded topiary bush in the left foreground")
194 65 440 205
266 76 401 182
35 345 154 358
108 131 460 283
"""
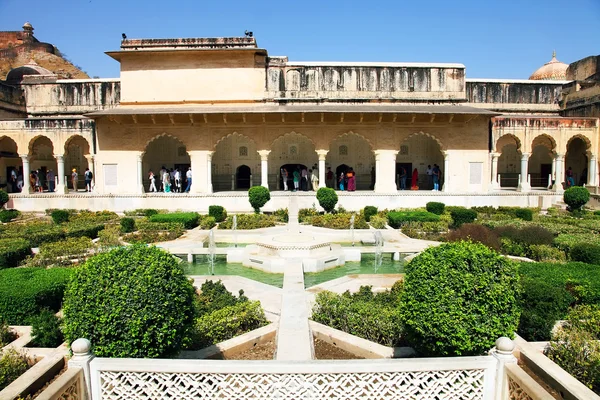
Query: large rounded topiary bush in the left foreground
63 245 194 358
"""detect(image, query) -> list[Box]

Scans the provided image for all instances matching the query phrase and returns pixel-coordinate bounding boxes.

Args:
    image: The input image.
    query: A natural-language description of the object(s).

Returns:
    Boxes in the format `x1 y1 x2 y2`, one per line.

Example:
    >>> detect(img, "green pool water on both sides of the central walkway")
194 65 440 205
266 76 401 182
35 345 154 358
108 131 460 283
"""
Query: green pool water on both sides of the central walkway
181 254 404 288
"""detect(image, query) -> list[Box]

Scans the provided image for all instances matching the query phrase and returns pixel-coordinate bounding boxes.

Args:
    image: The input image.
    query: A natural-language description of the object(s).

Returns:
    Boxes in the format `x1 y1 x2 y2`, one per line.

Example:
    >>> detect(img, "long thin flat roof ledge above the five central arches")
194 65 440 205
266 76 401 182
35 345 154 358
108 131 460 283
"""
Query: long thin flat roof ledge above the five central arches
85 104 501 117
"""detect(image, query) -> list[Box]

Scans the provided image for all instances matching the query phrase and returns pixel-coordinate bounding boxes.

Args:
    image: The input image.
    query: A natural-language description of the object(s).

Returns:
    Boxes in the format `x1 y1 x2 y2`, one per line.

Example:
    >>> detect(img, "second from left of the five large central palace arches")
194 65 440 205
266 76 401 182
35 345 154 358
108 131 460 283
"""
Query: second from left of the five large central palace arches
211 132 261 192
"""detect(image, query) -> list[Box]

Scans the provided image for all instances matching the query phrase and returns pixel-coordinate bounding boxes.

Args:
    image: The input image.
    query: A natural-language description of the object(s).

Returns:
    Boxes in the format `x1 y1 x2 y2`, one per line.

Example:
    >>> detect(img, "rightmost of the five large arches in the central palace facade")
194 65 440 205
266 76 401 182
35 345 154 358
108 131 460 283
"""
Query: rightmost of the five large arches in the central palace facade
396 133 446 190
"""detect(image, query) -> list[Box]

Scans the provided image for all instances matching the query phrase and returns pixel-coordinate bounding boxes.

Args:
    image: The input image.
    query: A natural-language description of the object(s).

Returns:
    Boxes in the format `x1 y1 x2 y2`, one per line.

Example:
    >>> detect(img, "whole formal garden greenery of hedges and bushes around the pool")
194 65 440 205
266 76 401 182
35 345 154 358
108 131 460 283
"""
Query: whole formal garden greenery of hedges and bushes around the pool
0 187 600 393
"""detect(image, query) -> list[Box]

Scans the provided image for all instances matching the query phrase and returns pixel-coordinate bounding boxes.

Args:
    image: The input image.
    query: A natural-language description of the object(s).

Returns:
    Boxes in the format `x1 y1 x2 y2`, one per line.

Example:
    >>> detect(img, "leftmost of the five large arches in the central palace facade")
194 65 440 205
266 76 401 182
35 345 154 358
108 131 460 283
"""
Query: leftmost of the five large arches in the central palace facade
142 135 191 192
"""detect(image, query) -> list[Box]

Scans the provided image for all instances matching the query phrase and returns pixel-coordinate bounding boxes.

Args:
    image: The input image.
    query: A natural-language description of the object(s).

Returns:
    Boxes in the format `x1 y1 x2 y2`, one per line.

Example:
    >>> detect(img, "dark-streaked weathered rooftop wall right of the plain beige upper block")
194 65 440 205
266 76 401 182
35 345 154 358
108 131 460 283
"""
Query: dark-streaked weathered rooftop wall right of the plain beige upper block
267 58 465 101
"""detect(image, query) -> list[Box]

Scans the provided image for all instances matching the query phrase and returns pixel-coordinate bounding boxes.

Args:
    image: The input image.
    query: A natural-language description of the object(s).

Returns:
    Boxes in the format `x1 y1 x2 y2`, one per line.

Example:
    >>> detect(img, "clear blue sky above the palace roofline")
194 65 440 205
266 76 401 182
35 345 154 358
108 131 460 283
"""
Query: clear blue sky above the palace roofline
0 0 600 79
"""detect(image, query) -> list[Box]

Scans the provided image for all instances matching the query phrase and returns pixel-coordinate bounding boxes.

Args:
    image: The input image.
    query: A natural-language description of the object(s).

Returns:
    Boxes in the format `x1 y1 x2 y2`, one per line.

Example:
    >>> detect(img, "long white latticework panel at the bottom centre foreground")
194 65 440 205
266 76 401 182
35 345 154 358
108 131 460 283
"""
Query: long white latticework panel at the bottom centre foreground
100 369 485 400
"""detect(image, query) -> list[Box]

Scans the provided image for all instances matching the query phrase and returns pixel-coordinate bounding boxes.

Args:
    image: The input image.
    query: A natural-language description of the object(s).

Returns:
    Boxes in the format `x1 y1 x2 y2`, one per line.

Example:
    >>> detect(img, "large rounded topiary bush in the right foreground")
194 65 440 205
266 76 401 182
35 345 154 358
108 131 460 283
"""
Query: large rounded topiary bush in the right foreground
401 242 521 356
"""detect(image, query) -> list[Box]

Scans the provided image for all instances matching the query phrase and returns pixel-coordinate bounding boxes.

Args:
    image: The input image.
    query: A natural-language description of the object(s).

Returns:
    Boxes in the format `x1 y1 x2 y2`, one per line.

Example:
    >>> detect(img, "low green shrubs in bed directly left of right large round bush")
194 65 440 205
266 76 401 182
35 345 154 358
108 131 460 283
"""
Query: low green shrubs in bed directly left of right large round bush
312 281 405 346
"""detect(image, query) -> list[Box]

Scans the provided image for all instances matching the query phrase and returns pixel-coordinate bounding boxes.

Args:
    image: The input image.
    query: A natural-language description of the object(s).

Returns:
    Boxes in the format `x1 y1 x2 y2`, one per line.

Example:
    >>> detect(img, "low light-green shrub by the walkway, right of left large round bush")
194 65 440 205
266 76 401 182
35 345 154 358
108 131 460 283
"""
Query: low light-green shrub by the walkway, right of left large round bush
191 301 268 349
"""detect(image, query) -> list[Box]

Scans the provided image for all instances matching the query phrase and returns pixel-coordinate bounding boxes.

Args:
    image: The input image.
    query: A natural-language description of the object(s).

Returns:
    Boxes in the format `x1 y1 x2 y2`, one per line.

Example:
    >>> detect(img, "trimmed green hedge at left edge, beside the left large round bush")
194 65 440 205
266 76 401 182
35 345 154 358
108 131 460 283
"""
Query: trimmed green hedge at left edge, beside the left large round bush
0 268 73 325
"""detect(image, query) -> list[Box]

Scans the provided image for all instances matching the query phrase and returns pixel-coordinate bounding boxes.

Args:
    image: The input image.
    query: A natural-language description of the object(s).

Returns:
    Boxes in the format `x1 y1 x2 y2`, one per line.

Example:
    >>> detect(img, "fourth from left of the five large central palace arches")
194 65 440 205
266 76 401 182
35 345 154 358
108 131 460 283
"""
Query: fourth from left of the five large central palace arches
325 132 375 190
